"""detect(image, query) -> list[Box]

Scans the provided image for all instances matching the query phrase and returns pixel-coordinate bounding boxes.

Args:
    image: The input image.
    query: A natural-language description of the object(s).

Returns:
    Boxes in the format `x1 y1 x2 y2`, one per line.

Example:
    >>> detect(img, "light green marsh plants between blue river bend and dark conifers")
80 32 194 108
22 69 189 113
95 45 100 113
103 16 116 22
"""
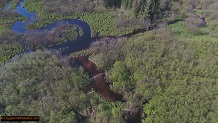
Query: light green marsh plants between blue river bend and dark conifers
24 0 134 36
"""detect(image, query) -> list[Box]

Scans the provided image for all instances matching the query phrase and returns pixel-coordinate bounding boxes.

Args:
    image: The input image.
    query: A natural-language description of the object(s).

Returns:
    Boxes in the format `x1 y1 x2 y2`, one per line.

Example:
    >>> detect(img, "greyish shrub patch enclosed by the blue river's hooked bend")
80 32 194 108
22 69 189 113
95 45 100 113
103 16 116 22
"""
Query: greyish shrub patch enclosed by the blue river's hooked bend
24 24 81 49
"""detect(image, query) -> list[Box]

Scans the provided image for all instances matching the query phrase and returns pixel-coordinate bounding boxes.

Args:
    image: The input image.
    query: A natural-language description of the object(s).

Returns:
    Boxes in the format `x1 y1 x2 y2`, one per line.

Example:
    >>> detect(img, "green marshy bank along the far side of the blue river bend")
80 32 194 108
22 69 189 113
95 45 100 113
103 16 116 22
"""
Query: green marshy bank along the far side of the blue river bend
20 0 149 37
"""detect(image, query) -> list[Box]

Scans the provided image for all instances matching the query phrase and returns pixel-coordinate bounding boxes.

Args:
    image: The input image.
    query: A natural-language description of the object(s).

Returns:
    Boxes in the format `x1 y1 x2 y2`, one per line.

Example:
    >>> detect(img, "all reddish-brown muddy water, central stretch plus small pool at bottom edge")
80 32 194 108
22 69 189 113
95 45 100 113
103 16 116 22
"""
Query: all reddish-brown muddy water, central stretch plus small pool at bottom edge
70 56 141 123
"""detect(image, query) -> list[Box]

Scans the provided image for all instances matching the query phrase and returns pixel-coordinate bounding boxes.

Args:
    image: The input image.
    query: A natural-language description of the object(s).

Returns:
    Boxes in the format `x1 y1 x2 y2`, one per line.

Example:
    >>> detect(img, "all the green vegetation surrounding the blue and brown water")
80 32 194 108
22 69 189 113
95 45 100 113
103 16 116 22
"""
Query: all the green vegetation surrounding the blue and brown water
0 0 218 123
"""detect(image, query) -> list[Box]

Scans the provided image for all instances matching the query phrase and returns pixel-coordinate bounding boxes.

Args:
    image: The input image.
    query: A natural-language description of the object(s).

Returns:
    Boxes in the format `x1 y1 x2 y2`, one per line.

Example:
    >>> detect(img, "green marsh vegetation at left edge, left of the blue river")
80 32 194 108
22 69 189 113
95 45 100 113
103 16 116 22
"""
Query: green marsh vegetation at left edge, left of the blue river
0 0 25 65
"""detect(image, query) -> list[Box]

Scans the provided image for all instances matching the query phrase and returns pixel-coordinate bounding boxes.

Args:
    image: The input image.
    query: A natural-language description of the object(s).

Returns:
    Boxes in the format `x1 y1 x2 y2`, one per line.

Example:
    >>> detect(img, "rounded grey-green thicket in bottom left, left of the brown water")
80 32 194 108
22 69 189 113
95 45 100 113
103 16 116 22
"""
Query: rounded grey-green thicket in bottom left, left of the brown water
0 51 90 122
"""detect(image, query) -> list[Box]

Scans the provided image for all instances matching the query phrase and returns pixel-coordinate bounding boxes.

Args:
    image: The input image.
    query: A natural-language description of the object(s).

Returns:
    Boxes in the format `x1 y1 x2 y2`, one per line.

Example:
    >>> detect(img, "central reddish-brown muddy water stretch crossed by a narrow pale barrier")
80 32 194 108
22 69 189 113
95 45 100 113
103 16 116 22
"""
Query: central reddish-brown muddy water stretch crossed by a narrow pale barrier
71 56 124 102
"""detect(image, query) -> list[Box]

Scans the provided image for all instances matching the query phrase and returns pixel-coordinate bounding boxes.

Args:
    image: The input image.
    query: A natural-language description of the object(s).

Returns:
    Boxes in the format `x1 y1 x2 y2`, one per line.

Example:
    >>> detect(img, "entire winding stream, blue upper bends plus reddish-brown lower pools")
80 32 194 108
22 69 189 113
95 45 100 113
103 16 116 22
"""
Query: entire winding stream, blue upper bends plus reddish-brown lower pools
3 0 144 123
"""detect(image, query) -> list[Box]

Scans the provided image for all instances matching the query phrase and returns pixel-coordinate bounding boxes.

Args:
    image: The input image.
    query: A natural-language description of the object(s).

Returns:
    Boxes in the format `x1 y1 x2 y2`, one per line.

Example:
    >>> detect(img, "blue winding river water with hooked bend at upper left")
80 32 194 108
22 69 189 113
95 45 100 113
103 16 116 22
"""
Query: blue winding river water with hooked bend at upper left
3 0 92 55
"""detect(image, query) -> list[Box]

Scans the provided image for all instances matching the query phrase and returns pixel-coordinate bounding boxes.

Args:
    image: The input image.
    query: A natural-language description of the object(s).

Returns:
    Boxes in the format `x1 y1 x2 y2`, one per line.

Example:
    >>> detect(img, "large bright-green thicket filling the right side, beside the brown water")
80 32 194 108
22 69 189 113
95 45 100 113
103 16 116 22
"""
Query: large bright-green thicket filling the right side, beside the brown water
92 29 218 122
